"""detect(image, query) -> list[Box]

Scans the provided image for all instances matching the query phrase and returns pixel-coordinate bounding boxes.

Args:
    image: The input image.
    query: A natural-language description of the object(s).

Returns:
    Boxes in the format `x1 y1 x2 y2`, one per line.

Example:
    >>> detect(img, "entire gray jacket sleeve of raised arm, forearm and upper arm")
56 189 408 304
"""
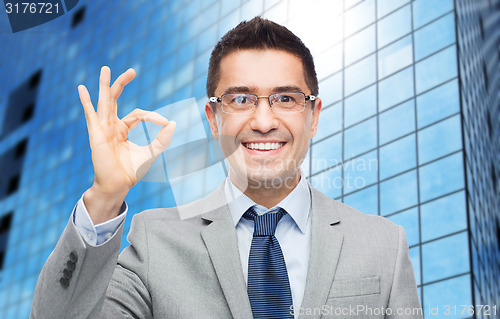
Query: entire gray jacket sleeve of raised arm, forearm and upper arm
30 214 152 319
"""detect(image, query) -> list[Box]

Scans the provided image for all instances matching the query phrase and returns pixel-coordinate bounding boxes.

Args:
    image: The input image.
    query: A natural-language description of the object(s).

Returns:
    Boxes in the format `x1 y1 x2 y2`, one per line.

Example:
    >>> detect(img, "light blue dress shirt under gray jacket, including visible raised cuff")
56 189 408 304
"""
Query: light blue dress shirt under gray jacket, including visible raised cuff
73 177 311 318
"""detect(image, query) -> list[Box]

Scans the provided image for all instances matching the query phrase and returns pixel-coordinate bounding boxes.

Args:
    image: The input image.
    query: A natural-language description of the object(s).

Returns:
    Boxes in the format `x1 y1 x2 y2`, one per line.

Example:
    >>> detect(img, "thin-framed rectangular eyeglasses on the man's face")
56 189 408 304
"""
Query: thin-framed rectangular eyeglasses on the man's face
209 92 316 114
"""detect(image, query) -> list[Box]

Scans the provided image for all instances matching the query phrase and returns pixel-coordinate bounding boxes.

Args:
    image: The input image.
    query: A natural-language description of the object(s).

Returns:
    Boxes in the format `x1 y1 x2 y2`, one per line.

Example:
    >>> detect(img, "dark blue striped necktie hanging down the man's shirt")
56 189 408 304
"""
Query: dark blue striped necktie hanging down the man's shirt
243 207 293 319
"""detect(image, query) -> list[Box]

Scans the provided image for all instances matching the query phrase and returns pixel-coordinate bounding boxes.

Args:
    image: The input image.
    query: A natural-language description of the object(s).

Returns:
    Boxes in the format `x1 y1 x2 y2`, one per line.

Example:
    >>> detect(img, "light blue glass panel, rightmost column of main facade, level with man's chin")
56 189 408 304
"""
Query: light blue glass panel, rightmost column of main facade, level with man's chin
419 152 464 202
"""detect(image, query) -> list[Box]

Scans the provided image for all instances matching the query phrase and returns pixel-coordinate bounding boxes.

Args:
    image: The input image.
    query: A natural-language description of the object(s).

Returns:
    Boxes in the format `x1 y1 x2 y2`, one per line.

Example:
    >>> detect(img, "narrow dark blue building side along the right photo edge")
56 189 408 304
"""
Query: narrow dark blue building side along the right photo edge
456 0 500 312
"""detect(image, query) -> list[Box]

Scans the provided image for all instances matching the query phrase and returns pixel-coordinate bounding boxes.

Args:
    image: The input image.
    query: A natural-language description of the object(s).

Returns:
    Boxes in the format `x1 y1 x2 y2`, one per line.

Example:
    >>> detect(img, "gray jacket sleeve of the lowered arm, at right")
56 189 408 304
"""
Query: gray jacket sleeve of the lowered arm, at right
386 226 422 319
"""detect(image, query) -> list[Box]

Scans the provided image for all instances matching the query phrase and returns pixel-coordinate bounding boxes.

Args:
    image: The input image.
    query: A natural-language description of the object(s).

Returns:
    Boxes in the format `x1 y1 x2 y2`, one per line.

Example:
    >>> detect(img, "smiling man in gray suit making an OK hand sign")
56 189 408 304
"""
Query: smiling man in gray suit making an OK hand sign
32 17 421 318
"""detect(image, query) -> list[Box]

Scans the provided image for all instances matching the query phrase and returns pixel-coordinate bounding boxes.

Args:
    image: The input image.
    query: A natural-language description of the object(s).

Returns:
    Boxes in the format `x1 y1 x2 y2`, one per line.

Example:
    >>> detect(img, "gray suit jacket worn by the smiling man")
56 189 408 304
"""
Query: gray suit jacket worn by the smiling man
31 185 422 319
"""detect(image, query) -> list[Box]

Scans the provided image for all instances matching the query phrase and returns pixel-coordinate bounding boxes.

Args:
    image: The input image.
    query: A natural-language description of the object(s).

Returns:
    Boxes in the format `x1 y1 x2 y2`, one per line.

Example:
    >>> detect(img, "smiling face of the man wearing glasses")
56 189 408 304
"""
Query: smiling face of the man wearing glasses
205 50 321 188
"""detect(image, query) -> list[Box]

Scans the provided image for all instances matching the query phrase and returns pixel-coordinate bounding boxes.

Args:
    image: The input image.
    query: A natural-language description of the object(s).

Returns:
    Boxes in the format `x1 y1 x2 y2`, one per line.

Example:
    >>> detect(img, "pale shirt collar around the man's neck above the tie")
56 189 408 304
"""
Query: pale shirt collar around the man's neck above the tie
224 176 311 233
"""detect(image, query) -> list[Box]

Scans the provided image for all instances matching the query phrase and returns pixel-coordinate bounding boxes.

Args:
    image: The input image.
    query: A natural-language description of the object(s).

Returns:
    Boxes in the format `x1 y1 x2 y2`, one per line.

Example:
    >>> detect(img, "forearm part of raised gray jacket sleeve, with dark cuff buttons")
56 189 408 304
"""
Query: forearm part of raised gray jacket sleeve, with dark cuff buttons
30 215 123 319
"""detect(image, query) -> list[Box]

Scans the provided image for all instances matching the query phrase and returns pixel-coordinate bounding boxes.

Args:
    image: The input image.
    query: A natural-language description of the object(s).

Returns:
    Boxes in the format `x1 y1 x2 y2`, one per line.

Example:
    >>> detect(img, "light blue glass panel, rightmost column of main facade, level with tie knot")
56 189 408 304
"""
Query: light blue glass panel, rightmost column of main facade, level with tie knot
420 192 467 241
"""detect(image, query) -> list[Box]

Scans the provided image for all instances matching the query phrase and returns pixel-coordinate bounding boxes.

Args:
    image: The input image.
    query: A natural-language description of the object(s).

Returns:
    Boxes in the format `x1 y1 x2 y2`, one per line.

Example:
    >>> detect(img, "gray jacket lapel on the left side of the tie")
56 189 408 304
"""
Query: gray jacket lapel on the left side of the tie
201 183 253 319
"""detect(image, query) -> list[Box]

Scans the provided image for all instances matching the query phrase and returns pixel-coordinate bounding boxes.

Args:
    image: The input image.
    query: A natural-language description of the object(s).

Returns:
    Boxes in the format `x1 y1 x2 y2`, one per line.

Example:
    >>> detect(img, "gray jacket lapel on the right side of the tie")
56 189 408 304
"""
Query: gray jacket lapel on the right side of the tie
299 185 344 319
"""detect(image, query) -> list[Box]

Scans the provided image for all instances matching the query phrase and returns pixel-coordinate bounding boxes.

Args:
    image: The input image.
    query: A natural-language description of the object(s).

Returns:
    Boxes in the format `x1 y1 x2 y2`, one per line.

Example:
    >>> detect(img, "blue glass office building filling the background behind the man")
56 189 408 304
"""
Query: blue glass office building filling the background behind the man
0 0 500 319
